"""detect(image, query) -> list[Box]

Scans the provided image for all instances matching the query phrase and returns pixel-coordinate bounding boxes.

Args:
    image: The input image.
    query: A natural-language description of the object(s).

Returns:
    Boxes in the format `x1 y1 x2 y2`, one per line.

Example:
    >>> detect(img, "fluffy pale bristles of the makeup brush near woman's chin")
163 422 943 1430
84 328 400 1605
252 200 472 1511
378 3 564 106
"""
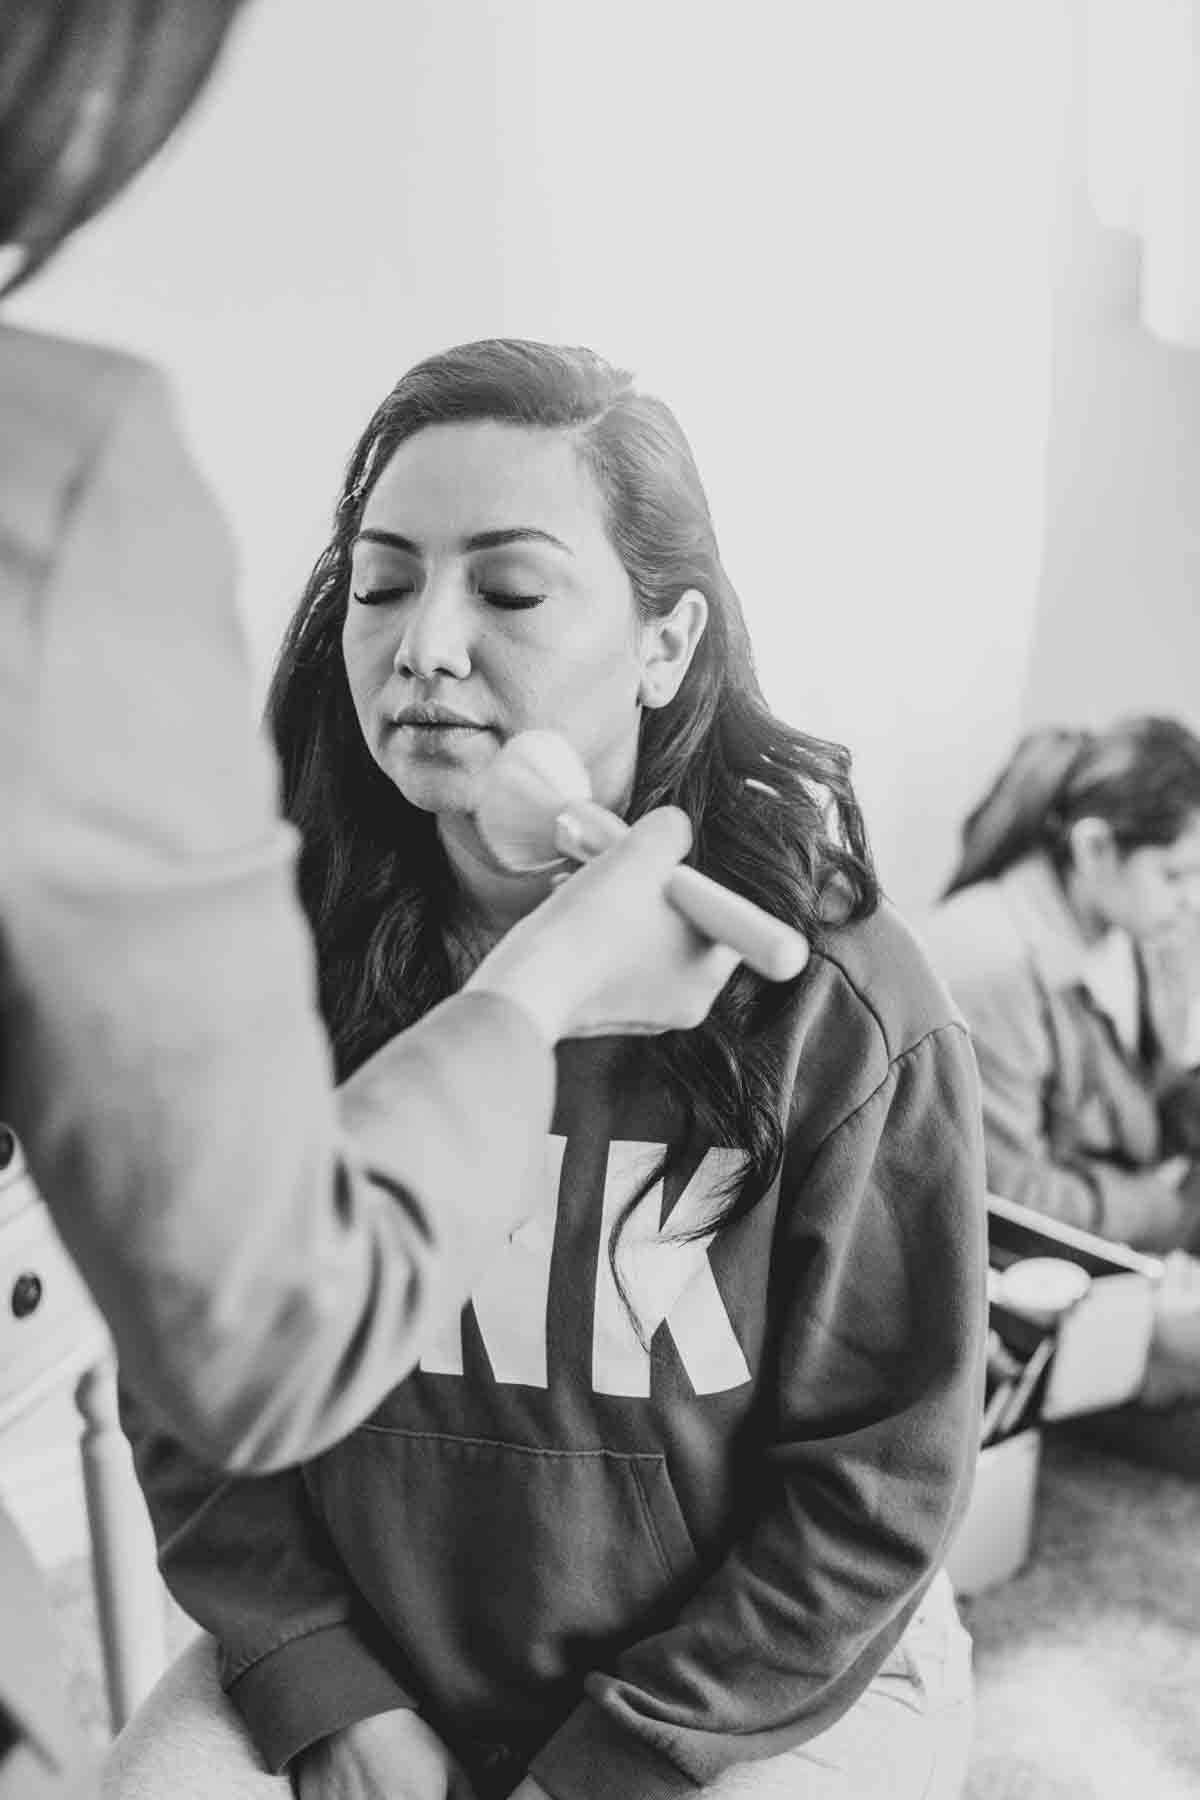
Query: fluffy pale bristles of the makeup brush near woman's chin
475 731 592 869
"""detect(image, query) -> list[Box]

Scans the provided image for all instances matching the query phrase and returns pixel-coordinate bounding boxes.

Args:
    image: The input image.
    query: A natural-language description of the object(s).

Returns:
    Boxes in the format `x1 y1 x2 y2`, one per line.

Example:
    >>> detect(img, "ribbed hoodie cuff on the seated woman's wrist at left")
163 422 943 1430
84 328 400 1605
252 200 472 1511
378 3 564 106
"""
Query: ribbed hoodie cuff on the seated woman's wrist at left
225 1625 416 1775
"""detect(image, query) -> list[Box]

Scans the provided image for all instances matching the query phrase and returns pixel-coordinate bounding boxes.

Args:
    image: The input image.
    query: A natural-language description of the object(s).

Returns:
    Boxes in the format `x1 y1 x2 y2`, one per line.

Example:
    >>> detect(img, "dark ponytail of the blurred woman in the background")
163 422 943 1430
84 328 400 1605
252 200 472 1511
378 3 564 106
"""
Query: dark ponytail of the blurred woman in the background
943 725 1094 900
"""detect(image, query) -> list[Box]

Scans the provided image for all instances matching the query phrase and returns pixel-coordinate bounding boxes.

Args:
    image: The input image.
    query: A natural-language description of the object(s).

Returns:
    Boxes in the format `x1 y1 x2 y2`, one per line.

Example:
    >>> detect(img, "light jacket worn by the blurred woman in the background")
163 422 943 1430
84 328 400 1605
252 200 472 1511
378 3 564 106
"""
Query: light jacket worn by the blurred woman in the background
921 855 1200 1249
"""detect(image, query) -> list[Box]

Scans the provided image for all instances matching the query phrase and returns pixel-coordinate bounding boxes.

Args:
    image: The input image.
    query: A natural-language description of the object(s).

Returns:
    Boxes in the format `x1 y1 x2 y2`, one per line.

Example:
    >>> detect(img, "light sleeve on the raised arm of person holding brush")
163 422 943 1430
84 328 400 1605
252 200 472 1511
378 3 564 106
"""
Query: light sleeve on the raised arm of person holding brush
0 364 552 1467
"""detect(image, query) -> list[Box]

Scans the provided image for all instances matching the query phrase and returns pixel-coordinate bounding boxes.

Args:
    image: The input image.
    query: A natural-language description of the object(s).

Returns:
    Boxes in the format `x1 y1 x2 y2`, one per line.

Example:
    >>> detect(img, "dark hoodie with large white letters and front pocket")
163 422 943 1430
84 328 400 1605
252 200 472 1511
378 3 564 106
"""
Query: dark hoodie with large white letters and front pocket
128 909 984 1800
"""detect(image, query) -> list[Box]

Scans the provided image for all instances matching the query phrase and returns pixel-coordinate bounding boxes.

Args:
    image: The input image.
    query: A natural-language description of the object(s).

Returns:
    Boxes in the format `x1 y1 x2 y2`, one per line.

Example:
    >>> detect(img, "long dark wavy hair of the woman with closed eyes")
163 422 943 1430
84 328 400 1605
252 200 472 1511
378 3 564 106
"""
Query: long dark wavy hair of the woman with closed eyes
268 340 880 1269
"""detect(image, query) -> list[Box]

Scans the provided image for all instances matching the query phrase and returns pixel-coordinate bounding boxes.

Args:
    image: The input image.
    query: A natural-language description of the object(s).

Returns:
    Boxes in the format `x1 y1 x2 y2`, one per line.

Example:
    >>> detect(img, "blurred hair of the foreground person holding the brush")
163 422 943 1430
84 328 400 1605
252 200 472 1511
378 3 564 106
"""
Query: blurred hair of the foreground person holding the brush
0 0 245 292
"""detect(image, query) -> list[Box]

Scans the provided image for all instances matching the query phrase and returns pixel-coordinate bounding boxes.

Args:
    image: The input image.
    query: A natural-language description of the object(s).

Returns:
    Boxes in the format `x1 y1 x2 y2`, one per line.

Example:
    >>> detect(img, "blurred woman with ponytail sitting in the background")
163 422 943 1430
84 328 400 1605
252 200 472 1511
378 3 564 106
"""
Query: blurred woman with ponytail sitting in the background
923 718 1200 1469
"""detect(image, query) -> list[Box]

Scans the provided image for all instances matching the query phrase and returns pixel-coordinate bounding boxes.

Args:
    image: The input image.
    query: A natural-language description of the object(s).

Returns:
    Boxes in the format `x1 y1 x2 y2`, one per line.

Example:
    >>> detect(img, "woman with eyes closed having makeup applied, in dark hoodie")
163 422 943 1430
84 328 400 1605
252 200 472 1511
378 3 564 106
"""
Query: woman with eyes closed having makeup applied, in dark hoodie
108 340 984 1800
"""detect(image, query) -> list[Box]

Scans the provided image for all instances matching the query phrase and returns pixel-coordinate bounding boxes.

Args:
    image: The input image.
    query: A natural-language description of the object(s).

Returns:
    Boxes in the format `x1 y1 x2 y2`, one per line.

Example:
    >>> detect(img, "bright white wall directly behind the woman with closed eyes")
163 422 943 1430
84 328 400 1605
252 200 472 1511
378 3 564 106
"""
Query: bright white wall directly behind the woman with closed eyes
7 0 1065 902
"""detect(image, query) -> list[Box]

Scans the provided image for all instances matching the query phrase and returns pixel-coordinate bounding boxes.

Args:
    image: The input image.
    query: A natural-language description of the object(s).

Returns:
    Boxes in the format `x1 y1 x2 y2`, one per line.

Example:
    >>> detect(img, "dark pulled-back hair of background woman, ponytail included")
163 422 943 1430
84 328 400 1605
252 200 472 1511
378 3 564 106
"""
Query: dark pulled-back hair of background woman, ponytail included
945 718 1200 898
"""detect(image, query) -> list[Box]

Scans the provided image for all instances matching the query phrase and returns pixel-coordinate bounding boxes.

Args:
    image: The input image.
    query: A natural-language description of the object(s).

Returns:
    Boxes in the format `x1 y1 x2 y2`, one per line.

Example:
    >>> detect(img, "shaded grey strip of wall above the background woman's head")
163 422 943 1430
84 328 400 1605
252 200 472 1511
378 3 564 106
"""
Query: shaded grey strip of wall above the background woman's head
1022 16 1200 729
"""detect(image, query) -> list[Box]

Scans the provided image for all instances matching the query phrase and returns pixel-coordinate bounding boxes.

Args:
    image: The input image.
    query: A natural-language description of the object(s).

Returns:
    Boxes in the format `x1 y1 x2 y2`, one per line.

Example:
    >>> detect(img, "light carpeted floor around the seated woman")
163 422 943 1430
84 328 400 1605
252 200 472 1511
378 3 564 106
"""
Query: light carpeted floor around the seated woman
44 1436 1200 1800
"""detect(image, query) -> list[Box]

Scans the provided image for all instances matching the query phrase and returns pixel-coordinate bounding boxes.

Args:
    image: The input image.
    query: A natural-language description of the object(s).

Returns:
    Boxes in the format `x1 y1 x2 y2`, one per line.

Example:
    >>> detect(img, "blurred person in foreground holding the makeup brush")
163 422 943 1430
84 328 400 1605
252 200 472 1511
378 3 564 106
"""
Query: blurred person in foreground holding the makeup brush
0 0 736 1800
